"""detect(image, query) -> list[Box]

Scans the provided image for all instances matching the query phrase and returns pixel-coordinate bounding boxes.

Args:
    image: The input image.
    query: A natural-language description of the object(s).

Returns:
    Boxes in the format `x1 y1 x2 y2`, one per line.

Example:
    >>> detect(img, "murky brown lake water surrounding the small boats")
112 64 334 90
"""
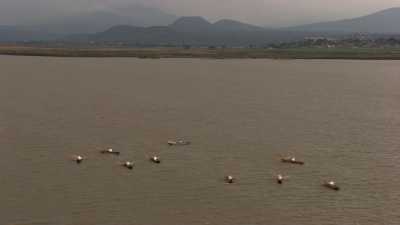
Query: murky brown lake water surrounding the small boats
0 56 400 225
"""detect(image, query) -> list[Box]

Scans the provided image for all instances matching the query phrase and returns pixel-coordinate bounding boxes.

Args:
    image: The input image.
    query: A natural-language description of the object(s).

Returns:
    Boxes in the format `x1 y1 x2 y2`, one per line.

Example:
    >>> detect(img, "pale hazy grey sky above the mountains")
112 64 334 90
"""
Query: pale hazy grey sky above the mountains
0 0 400 26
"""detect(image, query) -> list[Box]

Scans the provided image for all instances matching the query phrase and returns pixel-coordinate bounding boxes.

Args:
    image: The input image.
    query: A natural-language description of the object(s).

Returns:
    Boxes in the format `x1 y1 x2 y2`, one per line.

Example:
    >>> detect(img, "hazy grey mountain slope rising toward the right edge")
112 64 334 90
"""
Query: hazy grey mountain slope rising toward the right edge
289 8 400 34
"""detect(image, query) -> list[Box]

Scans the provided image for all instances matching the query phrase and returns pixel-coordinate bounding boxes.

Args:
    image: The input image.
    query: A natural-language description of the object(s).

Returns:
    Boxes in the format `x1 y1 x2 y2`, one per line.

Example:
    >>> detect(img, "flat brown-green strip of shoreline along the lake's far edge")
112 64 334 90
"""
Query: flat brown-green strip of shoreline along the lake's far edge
0 45 400 60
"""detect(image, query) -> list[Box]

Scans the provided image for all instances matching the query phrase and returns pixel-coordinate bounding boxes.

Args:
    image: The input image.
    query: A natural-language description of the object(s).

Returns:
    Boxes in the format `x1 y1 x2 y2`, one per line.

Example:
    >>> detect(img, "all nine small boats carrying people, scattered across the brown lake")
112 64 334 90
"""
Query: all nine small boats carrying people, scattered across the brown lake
74 140 340 191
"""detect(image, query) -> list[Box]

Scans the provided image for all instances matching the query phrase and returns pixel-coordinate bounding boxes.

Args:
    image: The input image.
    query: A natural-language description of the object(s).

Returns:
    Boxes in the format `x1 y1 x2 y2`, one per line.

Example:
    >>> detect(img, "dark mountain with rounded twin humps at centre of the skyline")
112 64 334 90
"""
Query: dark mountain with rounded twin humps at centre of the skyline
80 17 324 47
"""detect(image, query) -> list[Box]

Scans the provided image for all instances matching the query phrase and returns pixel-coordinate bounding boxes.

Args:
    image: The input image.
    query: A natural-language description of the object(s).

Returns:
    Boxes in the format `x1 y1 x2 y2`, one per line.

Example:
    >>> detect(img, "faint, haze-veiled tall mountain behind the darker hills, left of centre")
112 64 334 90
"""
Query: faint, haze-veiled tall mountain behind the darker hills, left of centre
34 4 177 35
